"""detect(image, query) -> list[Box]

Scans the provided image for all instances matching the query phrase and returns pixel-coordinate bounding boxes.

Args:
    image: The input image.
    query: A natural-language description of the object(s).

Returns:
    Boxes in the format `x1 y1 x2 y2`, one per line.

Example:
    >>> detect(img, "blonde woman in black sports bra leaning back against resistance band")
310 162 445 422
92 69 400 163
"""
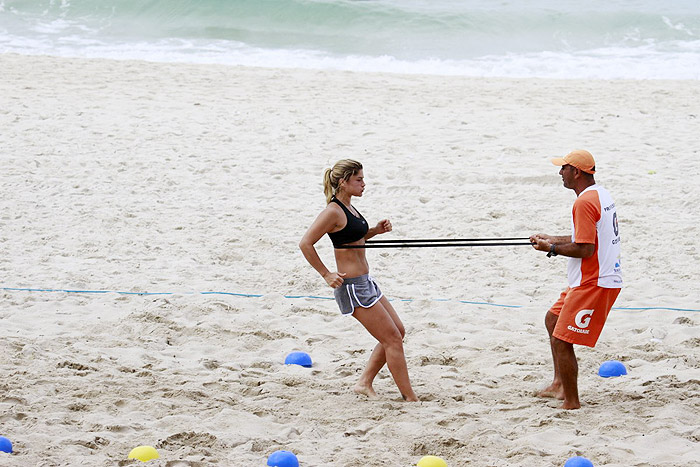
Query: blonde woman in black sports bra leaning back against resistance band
299 159 418 402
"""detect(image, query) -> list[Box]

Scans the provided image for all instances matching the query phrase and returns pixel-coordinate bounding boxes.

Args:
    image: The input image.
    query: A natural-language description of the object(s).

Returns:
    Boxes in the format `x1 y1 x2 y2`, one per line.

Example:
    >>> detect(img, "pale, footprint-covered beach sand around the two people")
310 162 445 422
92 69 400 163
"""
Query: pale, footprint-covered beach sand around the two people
0 55 700 467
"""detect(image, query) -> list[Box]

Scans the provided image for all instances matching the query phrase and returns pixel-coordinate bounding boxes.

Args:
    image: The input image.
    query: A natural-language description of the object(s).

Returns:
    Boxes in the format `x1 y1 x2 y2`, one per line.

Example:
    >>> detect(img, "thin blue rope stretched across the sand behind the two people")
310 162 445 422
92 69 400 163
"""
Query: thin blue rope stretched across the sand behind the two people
0 287 700 312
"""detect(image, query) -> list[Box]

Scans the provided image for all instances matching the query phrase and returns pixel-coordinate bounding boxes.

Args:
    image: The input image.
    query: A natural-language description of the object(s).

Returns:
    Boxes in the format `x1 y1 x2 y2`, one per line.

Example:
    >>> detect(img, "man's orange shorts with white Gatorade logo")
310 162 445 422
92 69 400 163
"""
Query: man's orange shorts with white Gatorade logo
549 285 620 347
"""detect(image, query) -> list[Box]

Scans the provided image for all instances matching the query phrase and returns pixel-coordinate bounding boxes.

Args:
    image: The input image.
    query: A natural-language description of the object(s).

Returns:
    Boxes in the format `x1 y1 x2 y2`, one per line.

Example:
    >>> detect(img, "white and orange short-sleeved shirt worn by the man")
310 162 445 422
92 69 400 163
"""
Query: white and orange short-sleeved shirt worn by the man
568 185 622 289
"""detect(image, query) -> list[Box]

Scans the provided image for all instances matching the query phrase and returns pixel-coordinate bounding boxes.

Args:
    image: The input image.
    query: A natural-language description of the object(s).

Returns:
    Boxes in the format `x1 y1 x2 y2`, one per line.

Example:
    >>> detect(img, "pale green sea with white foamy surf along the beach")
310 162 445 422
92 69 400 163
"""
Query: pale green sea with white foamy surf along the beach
0 0 700 79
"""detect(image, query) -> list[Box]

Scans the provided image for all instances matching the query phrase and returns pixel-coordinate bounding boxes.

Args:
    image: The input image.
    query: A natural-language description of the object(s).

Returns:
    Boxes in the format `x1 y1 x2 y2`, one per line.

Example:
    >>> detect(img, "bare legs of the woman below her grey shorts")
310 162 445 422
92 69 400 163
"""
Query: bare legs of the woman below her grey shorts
353 297 418 401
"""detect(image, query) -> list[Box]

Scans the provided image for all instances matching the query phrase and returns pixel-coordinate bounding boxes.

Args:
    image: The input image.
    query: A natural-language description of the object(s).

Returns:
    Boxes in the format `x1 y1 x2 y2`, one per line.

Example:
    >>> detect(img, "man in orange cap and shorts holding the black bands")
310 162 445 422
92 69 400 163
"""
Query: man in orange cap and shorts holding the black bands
530 149 622 409
